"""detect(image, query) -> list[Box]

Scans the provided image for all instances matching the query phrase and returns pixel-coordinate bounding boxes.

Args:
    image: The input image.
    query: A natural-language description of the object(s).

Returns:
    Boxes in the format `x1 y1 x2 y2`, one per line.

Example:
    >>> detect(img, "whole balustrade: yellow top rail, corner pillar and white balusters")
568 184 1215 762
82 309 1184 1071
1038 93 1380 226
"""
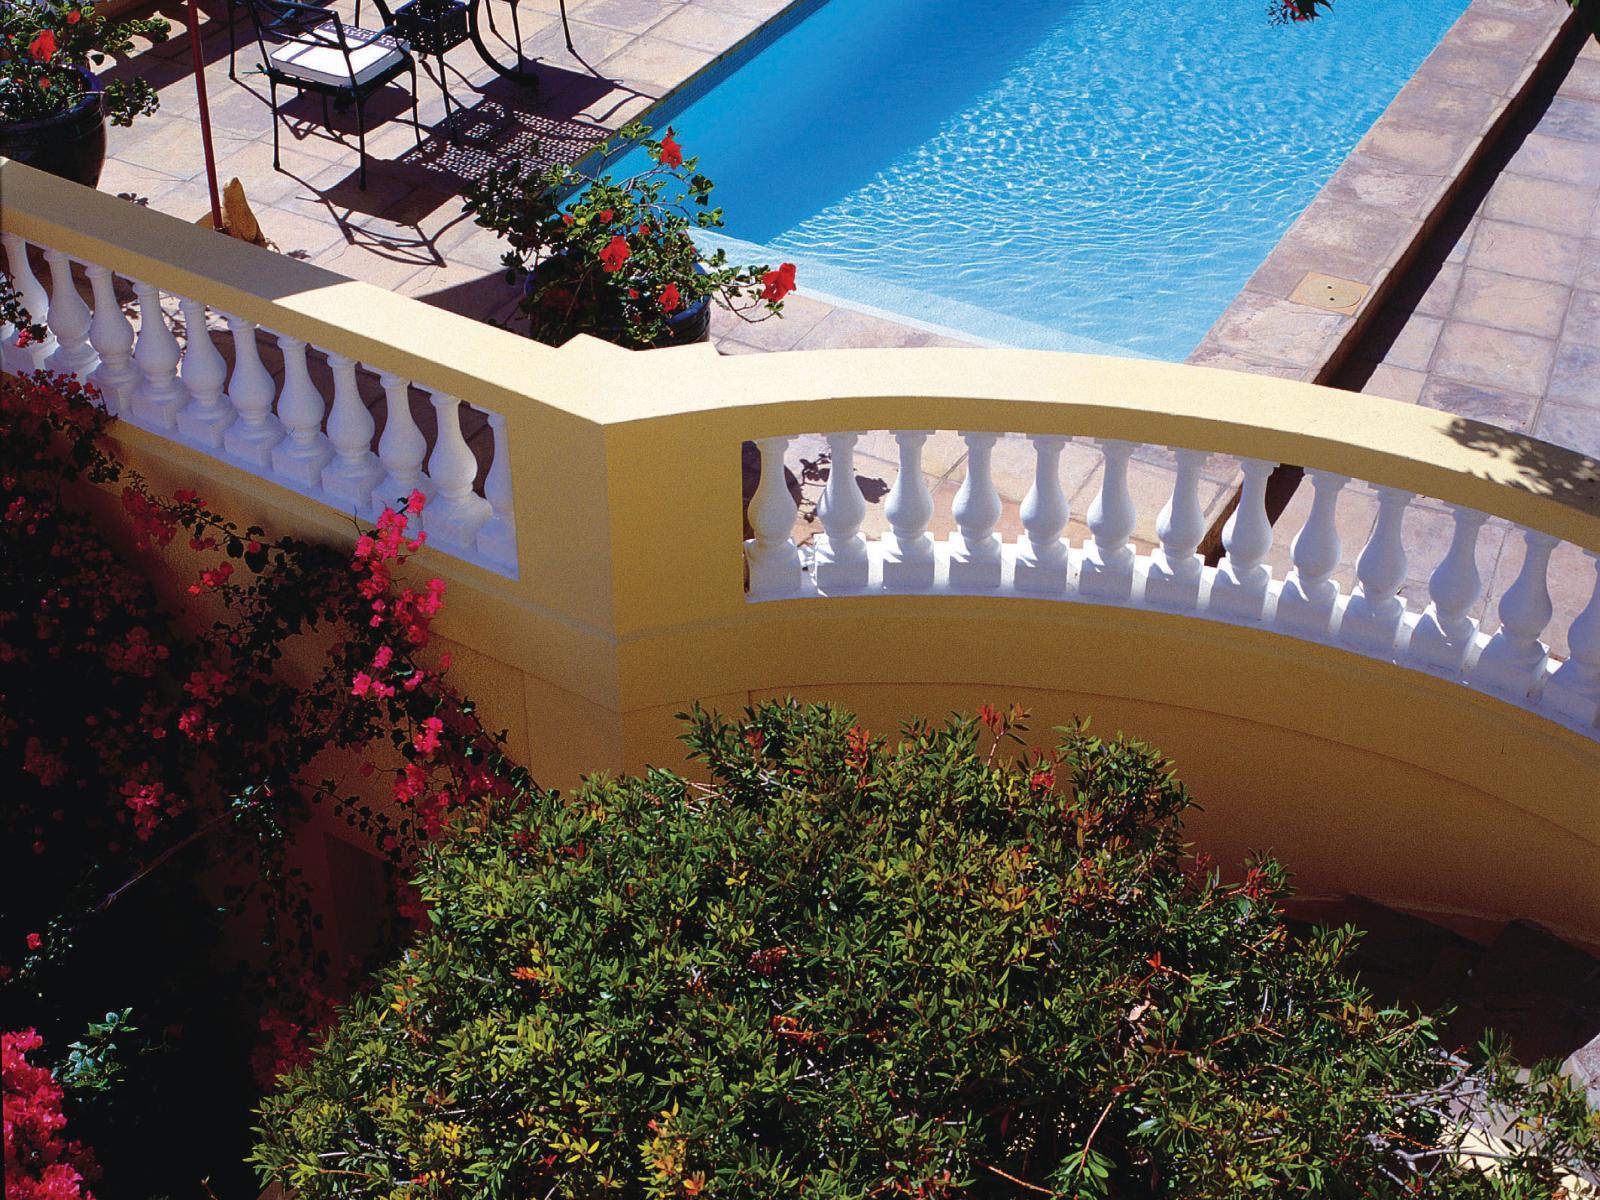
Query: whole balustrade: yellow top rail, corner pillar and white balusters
0 160 1600 738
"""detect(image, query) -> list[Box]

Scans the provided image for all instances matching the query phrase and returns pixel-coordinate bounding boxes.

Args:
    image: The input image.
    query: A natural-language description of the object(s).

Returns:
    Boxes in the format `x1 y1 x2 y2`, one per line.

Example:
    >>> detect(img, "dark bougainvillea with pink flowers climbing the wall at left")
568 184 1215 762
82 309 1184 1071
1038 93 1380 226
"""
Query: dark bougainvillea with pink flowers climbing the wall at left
0 373 531 1195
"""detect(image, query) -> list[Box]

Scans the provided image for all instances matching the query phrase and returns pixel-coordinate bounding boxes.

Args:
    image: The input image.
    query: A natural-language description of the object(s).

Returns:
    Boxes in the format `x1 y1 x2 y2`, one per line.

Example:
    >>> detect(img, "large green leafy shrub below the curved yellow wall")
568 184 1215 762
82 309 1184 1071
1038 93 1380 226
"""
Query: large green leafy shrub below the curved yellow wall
254 704 1600 1200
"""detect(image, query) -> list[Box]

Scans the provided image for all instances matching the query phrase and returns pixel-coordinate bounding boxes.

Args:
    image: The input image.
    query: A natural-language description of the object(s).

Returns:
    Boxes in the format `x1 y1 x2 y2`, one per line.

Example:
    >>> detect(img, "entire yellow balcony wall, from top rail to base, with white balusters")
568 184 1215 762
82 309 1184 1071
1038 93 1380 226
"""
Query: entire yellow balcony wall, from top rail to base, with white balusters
9 162 1600 944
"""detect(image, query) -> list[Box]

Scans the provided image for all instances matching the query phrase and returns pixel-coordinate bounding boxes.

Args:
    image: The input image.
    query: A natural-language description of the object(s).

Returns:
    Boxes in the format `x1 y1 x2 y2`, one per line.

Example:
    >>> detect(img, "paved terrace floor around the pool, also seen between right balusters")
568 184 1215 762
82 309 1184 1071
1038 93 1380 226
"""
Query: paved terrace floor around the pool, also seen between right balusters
101 0 1600 653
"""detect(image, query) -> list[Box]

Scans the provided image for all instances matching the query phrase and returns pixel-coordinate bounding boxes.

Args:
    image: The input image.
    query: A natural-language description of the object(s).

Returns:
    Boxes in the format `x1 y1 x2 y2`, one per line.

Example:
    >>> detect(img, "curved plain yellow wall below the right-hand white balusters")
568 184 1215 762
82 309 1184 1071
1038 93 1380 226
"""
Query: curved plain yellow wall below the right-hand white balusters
608 597 1600 944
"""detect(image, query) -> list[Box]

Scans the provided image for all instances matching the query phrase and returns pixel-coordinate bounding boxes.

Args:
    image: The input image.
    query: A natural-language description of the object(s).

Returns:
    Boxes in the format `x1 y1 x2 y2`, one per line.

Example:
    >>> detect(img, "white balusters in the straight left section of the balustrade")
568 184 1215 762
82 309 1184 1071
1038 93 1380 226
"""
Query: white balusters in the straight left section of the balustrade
0 232 517 578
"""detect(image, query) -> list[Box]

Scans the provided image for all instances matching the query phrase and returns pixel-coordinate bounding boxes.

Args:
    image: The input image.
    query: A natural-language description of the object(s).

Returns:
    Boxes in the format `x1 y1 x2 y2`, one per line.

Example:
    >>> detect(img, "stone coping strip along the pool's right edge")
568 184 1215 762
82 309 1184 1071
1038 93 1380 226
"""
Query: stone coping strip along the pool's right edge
1187 0 1584 384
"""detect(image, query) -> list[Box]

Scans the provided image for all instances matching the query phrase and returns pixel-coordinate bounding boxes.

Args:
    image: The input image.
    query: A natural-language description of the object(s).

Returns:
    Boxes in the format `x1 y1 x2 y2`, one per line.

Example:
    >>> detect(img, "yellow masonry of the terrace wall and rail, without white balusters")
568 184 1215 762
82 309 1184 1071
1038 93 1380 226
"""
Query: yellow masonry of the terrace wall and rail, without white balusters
9 160 1600 946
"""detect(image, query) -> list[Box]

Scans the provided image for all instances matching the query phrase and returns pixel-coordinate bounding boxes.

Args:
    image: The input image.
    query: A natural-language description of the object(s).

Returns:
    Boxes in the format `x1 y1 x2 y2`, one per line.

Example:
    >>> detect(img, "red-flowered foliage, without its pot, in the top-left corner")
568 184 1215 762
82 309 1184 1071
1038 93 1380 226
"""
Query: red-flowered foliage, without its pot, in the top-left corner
0 0 170 125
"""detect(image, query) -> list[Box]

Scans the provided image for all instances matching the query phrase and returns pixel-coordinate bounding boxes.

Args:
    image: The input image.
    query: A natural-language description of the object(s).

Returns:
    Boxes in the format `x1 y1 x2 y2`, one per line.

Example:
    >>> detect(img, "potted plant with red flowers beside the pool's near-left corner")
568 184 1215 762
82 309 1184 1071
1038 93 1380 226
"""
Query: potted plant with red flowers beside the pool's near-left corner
466 123 795 349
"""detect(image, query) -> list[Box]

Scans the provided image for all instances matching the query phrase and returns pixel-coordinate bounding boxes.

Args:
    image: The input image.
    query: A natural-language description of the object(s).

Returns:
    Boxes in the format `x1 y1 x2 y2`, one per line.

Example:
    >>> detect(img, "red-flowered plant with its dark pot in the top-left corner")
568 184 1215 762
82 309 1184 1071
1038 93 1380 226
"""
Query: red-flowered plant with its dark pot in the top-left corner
0 0 170 187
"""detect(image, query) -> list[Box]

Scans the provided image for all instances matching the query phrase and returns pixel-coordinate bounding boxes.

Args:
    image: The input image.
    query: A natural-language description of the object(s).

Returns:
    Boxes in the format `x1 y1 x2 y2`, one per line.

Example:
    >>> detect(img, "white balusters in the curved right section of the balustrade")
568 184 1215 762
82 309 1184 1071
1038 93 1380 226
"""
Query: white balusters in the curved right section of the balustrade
746 430 1600 736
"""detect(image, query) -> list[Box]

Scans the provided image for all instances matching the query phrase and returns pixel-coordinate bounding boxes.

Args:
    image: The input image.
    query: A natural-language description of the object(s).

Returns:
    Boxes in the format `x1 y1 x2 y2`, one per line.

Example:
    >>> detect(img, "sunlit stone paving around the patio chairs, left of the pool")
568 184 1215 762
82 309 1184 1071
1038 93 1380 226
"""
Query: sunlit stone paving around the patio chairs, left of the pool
101 0 812 305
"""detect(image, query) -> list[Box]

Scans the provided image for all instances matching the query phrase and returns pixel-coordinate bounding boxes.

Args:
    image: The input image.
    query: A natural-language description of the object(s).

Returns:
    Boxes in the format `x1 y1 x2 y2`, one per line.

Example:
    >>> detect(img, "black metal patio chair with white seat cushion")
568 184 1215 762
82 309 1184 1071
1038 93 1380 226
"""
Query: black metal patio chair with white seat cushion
243 0 422 190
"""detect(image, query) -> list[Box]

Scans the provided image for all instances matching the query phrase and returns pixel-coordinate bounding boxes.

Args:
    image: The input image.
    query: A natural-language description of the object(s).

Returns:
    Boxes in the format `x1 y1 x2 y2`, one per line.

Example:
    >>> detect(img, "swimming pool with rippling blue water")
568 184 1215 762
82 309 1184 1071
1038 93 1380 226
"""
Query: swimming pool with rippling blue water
611 0 1466 360
